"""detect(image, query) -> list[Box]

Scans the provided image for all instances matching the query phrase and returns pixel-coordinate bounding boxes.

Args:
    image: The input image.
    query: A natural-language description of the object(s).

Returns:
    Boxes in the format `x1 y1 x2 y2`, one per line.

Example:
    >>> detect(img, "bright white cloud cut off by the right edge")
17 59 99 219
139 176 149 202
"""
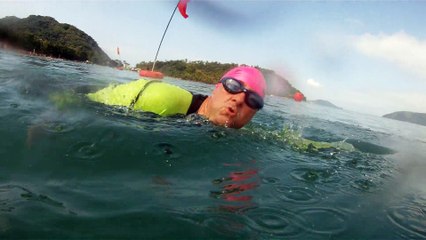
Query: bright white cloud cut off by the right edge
354 32 426 79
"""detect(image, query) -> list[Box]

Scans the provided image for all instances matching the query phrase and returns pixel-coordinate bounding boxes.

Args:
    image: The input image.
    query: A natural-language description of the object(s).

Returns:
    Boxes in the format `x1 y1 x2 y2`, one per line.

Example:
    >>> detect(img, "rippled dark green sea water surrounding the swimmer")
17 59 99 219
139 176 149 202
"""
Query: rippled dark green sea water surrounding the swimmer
0 51 426 239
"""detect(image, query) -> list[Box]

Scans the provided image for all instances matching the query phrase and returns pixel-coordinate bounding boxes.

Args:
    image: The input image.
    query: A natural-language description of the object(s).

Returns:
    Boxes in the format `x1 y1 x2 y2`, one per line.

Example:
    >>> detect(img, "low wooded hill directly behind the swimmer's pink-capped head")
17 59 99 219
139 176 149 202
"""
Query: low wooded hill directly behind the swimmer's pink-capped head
136 60 299 98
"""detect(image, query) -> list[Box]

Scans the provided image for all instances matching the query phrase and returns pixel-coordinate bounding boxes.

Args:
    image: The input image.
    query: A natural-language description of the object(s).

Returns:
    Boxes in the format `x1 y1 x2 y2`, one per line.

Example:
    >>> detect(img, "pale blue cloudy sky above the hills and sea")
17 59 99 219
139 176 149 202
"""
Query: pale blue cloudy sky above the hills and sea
0 0 426 116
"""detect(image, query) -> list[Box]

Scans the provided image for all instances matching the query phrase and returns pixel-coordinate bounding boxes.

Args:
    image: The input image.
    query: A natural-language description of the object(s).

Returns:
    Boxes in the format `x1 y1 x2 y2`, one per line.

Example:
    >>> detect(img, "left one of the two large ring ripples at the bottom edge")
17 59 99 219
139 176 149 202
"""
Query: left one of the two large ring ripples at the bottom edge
247 207 307 237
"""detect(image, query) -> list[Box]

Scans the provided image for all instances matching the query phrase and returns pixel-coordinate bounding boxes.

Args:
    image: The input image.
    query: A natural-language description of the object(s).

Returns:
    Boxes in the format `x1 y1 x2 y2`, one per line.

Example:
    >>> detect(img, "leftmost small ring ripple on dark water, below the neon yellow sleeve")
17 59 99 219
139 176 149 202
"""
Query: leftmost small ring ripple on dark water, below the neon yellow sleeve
67 141 104 160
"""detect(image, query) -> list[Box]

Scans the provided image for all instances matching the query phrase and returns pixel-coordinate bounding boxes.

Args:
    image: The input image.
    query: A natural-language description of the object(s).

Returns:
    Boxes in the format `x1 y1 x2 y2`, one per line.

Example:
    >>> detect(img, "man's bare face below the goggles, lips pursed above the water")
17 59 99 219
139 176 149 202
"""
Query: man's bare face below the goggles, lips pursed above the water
208 84 257 128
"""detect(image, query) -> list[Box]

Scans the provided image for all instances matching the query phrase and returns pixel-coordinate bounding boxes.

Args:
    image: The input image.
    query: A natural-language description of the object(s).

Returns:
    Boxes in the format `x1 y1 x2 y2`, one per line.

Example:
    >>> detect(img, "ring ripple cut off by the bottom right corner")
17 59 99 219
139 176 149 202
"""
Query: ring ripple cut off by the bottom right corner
387 198 426 239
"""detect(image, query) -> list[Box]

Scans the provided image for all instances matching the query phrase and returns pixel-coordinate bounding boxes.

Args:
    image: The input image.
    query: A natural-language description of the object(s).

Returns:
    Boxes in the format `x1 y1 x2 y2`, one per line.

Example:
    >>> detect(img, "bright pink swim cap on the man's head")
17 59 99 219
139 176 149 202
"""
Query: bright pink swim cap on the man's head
222 66 266 98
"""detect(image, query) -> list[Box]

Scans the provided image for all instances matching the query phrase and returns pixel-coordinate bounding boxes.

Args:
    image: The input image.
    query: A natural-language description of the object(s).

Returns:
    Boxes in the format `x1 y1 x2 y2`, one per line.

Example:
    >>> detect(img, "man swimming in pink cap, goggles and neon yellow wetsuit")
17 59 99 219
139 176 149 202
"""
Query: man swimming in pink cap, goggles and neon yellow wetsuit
87 66 266 129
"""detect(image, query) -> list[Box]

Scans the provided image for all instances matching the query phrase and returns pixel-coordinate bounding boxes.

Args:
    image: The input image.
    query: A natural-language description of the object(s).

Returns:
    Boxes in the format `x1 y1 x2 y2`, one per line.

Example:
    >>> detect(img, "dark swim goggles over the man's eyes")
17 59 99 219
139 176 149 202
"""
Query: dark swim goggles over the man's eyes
220 78 263 109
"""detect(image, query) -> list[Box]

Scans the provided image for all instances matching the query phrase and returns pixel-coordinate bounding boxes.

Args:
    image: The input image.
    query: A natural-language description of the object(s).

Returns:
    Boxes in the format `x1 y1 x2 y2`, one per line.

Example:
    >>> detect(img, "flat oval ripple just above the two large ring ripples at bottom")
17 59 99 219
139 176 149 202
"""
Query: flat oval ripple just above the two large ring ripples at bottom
274 185 321 204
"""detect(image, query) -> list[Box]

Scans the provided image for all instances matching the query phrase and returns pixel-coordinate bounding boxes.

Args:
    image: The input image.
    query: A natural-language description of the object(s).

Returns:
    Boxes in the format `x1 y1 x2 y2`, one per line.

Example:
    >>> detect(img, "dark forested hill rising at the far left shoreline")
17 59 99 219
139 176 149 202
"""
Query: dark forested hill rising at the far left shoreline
0 15 111 65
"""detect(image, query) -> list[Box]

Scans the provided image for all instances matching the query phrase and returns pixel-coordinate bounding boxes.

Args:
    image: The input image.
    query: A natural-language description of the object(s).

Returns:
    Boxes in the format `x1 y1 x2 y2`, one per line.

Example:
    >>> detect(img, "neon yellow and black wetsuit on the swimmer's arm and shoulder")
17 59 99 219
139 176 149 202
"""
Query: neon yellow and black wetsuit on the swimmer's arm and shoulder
87 79 206 116
